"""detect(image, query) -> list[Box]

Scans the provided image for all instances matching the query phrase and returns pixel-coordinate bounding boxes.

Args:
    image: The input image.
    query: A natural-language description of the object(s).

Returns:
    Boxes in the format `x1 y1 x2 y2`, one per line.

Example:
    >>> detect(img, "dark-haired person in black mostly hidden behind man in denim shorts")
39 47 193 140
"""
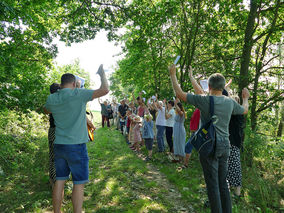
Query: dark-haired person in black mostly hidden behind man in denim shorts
48 83 60 188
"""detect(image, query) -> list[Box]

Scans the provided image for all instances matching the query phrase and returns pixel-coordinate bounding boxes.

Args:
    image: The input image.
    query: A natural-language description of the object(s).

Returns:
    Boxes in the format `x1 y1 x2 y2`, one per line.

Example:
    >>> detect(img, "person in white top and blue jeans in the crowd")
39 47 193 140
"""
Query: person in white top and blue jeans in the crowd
154 101 166 152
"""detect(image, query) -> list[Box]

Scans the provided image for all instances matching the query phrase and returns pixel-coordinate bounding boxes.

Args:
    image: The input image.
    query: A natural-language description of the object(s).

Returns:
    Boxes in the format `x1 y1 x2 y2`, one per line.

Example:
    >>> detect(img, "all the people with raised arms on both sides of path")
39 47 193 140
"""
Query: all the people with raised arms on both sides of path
45 62 249 212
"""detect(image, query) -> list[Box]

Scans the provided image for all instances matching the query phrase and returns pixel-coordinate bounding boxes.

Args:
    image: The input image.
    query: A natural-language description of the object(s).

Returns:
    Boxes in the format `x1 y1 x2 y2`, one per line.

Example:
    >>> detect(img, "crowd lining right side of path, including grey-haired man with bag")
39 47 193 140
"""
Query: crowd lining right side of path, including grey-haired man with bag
97 67 249 212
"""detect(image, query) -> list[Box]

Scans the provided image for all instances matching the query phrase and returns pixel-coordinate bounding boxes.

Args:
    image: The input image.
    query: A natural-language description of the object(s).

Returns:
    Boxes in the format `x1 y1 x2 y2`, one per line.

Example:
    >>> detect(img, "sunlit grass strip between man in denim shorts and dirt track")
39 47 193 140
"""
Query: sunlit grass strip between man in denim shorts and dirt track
81 128 194 212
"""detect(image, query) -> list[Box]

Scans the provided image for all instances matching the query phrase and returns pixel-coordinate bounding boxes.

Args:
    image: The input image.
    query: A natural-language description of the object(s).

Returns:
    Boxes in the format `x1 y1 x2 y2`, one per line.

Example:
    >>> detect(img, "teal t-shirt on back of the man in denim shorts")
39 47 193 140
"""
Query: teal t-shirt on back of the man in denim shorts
45 88 94 144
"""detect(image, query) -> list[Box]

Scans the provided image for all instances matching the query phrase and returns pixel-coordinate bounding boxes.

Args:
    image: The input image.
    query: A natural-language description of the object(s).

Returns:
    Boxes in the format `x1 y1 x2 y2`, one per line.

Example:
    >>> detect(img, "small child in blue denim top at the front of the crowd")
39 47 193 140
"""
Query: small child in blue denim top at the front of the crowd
142 113 154 161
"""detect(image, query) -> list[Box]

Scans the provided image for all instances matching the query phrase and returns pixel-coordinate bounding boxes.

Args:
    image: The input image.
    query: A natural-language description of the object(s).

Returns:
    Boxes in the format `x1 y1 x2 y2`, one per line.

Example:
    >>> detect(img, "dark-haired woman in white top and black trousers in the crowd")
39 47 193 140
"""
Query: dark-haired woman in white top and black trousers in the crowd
165 100 175 153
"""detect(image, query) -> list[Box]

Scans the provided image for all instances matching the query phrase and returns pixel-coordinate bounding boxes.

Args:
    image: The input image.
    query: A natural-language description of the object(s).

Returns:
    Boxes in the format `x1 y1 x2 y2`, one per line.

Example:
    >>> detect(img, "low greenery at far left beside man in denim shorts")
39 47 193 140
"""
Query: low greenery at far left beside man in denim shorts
0 111 51 212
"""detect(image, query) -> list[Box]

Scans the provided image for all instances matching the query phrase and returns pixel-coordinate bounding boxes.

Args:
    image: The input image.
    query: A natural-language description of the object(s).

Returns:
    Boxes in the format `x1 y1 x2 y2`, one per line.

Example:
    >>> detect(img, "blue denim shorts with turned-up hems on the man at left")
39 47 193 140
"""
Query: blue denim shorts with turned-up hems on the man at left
54 143 89 184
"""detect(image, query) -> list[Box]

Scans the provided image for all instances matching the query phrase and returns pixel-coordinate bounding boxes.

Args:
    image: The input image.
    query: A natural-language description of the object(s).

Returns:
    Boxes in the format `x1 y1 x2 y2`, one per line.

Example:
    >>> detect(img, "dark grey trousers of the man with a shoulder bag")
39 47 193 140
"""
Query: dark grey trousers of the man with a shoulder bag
199 137 232 213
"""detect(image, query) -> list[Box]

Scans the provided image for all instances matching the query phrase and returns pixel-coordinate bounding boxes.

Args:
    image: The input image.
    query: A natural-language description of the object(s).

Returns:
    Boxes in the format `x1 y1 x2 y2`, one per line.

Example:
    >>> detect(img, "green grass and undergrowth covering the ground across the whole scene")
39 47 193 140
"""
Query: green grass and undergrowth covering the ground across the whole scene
0 112 284 213
